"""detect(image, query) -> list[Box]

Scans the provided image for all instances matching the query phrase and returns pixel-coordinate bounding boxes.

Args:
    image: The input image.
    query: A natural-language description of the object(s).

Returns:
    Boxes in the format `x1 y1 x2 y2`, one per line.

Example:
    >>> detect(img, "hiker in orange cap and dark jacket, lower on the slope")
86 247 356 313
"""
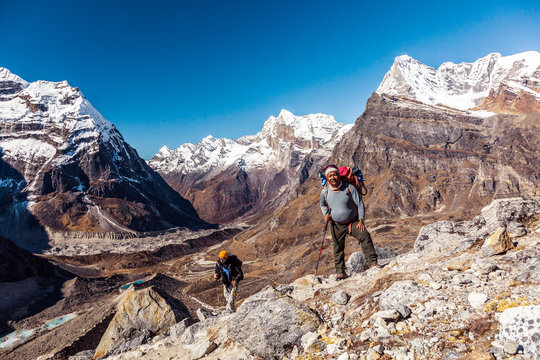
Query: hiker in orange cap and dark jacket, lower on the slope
214 250 244 311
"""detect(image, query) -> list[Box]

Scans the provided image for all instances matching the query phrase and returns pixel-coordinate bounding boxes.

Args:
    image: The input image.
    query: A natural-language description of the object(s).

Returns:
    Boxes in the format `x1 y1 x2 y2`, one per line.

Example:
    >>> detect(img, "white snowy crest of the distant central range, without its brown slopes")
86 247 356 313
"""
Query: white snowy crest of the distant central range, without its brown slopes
149 109 352 177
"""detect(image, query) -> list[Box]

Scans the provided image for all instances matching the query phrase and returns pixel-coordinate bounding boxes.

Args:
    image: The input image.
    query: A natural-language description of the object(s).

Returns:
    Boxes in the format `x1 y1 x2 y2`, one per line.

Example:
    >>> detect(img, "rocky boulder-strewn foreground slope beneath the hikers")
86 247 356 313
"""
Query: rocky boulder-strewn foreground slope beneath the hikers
20 198 540 360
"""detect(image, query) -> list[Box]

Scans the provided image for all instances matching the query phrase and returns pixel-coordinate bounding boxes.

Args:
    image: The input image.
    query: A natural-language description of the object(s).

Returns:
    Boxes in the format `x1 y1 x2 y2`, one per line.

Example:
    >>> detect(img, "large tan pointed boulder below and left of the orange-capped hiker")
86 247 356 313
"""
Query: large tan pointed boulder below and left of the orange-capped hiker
94 287 190 359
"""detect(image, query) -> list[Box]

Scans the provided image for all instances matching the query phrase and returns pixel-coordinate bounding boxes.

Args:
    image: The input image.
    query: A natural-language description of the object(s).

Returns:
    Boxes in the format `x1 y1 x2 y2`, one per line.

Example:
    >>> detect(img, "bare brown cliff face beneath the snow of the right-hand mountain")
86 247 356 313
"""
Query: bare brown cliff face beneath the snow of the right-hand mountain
333 94 540 217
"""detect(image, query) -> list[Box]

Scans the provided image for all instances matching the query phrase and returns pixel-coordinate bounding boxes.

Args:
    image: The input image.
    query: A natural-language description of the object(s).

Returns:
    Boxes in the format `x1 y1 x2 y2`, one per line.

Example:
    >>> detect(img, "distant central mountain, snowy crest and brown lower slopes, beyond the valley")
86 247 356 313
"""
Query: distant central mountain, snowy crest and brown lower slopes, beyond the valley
149 110 352 222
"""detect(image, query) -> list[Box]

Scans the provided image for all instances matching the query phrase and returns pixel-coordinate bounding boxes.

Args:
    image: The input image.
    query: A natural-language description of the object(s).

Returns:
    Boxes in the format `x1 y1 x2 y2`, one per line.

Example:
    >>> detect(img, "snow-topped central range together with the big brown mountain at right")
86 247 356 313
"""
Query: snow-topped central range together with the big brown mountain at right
149 51 540 222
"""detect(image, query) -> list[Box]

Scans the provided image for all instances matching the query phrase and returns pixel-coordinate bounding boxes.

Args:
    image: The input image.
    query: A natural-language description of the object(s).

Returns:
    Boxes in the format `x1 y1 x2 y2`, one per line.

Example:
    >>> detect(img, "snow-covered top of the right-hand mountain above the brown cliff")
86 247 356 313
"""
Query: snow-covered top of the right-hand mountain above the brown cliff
377 51 540 116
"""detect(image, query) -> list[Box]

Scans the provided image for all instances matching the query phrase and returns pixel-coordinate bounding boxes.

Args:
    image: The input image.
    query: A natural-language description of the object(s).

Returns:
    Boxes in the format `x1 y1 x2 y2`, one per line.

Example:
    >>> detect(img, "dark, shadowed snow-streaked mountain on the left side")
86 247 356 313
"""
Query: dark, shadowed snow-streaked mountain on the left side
0 68 202 250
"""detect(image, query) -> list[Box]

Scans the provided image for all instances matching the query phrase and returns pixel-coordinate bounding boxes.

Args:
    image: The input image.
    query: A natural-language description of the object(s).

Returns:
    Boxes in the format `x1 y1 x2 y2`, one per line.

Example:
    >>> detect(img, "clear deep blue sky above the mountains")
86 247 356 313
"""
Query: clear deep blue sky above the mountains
0 0 540 159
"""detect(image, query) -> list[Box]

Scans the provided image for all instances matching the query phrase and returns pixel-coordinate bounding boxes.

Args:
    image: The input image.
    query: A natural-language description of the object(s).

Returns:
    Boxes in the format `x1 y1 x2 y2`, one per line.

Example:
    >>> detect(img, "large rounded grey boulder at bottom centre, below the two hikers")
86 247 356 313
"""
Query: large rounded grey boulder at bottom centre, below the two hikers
227 286 320 359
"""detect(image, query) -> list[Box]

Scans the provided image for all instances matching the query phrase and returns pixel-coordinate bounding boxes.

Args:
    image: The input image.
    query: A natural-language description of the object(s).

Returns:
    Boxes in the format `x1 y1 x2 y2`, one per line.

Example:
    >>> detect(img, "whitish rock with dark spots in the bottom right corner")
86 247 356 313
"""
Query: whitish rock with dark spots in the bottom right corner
499 305 540 357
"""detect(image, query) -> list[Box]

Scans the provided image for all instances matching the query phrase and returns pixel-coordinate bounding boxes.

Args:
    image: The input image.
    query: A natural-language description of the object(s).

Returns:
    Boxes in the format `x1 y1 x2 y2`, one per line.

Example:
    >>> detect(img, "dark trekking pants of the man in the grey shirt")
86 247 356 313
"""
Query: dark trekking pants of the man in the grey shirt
330 221 377 274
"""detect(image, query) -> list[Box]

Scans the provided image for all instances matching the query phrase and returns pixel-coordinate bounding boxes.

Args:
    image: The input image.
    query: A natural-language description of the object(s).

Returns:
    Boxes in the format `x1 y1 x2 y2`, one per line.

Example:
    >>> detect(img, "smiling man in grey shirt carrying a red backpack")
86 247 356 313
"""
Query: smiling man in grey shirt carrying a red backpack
320 165 380 280
